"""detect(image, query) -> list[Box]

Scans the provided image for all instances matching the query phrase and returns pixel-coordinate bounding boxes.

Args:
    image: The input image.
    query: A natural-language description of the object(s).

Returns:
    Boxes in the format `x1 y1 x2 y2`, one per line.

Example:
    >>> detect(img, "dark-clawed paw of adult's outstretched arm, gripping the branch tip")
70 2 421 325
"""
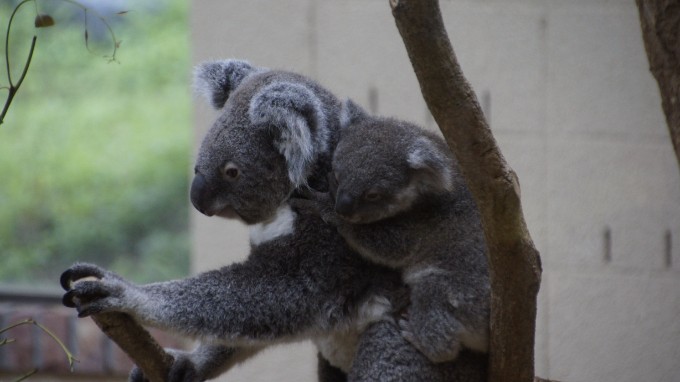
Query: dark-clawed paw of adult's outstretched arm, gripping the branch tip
59 263 132 317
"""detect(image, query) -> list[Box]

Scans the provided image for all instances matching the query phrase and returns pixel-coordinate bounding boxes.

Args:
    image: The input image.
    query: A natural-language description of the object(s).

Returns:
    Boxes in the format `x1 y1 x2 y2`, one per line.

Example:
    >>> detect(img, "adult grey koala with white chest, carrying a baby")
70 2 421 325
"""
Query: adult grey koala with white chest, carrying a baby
61 60 486 381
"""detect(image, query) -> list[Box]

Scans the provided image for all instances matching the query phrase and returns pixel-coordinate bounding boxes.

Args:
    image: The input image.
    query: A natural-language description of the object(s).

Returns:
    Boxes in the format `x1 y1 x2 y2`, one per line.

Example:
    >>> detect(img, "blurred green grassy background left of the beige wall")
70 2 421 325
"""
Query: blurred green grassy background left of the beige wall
0 0 192 287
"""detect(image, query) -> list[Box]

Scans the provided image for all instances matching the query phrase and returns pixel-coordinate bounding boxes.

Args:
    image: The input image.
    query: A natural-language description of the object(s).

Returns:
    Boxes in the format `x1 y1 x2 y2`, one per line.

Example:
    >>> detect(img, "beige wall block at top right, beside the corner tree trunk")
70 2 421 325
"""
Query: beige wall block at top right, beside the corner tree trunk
546 1 666 137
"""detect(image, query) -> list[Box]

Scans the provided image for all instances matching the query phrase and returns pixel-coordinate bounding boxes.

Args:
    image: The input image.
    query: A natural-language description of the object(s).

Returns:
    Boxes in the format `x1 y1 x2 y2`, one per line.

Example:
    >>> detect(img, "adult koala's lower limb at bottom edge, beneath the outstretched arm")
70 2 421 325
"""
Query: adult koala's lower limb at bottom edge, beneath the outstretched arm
129 343 261 382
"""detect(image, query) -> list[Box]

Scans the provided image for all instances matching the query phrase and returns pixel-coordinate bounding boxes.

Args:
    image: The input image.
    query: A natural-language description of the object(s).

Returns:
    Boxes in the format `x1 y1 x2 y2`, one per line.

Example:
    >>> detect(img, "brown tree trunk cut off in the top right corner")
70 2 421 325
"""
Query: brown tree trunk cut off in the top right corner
635 0 680 170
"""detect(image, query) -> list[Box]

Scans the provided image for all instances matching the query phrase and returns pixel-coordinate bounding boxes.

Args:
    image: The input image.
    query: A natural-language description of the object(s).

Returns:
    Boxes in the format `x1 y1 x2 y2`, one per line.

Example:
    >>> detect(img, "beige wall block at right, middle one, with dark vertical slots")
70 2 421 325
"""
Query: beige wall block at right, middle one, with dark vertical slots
544 137 680 268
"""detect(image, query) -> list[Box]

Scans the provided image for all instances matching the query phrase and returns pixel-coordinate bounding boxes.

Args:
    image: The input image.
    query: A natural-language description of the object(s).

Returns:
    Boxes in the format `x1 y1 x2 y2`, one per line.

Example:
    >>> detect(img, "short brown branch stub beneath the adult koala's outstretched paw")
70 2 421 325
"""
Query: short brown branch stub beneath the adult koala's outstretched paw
92 313 173 382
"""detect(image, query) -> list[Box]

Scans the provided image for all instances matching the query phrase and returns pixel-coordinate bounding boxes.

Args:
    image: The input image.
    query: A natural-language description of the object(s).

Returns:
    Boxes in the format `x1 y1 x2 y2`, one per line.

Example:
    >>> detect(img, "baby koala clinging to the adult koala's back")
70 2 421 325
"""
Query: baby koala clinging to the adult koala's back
294 101 490 362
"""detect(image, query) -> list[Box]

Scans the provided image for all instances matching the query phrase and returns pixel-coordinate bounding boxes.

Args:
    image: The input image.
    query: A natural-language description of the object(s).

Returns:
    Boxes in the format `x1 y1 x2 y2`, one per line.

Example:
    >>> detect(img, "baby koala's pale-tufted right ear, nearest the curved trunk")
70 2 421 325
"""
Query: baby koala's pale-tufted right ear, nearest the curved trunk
408 136 455 192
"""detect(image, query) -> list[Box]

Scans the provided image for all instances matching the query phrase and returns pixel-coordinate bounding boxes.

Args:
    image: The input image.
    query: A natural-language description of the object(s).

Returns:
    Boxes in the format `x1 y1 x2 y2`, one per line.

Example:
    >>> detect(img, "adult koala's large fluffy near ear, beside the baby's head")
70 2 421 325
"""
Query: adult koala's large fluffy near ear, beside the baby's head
249 82 330 186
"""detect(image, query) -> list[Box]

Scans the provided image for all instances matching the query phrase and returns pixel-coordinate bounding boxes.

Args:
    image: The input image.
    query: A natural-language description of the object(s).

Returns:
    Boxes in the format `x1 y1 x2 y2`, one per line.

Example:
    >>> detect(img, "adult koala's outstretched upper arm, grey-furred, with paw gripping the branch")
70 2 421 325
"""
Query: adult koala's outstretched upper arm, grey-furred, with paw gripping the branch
61 260 333 346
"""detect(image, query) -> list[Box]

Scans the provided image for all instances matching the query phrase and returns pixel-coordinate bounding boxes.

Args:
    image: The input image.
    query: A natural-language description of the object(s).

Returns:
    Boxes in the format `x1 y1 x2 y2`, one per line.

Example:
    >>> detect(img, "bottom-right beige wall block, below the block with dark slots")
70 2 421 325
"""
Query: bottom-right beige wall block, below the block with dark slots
545 271 680 382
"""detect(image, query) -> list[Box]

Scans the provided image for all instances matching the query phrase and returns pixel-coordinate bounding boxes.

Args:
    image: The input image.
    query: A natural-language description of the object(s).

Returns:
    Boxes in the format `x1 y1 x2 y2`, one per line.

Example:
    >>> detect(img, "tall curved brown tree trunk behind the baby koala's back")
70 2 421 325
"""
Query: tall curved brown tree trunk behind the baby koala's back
390 0 541 382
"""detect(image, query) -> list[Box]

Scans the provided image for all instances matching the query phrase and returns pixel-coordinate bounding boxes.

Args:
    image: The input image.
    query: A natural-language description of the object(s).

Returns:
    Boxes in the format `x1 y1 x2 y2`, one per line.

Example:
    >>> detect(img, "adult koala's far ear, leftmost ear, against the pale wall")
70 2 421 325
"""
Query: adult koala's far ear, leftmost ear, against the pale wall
194 60 256 109
